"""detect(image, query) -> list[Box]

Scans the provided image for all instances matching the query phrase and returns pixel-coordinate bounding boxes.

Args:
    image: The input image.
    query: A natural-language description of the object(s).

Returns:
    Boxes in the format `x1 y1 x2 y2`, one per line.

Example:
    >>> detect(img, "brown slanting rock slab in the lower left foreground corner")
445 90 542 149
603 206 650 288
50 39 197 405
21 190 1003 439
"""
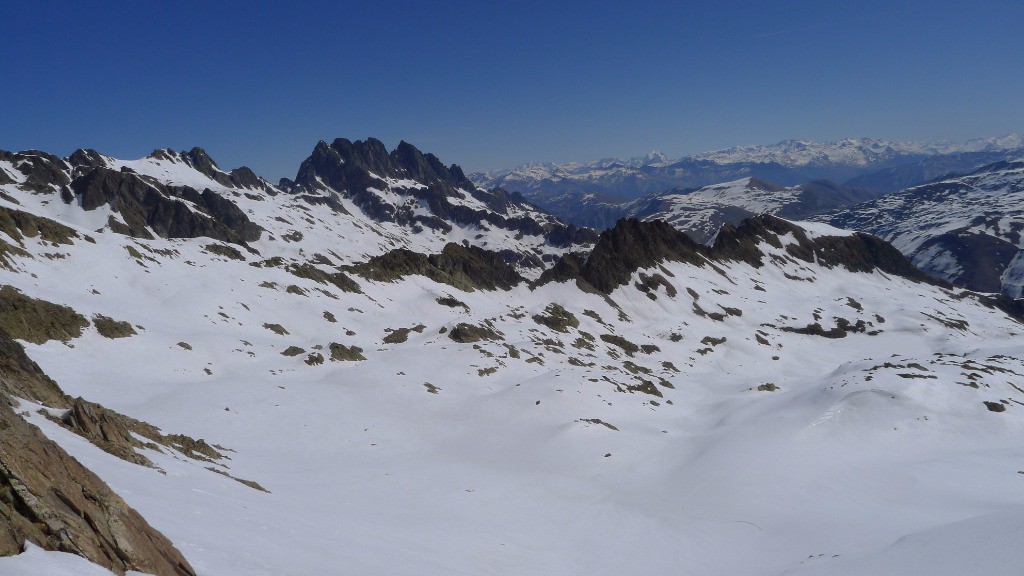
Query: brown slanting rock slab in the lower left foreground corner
0 330 195 576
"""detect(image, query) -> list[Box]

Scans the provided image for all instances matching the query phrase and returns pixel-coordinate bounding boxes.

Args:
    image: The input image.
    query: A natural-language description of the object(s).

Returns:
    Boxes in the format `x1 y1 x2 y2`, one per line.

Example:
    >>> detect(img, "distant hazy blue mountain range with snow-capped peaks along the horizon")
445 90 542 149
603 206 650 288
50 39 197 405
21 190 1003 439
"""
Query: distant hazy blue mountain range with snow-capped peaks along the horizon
471 134 1022 227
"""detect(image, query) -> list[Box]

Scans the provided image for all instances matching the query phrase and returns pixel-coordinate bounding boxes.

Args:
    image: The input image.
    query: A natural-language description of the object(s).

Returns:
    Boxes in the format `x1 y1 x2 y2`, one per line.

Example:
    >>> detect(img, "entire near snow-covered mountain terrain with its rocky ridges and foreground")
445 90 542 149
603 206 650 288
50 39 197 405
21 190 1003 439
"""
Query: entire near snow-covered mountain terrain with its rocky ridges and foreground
0 140 1024 576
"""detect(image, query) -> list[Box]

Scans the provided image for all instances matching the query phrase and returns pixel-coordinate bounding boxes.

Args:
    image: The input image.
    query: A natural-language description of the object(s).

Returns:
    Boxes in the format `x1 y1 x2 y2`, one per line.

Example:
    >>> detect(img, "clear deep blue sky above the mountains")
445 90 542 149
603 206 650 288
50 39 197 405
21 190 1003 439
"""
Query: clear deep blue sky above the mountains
0 0 1024 179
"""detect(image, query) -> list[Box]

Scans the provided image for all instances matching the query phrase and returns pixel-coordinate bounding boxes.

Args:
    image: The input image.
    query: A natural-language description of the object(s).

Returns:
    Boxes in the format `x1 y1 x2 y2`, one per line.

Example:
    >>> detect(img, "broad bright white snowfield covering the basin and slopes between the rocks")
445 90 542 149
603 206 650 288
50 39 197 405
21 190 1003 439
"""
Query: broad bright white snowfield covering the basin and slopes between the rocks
0 154 1024 576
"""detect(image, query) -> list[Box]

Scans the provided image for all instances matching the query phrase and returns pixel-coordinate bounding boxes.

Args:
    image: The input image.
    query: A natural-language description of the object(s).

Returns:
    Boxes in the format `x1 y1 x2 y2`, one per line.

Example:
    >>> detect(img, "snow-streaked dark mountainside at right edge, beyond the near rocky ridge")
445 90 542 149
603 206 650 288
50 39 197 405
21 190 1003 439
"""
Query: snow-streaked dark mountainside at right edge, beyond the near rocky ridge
815 160 1024 297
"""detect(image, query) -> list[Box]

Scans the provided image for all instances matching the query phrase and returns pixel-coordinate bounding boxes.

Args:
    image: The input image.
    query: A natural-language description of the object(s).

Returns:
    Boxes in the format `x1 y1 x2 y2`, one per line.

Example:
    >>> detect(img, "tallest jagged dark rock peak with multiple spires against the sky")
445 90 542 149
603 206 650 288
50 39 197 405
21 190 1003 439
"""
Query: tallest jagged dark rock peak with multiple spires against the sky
282 138 596 246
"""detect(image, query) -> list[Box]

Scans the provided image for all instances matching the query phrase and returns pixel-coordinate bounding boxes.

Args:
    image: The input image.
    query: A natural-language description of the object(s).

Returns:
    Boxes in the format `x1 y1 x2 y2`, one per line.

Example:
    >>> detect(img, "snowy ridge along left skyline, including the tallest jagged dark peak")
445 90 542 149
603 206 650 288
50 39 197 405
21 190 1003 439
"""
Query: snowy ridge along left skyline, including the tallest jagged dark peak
0 138 597 276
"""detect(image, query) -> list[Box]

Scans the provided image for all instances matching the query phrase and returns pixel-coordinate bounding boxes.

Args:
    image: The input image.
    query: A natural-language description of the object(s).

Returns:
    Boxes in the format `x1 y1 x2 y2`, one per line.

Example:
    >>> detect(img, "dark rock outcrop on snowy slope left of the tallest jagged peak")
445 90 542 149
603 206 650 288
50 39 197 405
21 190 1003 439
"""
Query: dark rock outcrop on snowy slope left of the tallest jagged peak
65 167 262 243
